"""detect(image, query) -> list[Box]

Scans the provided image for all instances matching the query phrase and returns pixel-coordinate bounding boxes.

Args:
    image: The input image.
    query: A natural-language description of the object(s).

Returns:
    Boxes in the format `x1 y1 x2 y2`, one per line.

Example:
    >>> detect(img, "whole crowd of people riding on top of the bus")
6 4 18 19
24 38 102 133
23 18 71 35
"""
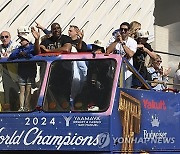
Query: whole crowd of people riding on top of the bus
0 21 180 111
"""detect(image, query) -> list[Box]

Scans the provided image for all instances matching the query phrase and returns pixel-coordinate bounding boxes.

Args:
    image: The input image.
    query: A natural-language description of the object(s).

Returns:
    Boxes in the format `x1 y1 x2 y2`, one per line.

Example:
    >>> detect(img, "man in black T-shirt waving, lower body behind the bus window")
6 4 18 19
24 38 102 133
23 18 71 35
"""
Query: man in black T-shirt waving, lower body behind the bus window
31 23 73 110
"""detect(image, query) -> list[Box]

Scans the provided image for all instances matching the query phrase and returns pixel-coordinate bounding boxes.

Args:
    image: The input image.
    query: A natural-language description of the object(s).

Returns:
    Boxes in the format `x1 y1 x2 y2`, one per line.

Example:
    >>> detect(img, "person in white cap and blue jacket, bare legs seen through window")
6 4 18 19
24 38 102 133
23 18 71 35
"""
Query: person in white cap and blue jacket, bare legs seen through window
8 28 36 111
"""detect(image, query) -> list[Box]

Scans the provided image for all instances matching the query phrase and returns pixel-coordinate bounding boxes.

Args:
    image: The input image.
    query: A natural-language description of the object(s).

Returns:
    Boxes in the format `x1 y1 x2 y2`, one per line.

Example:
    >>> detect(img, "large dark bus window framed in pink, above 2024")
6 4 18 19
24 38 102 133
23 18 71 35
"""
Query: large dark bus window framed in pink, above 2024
44 59 116 112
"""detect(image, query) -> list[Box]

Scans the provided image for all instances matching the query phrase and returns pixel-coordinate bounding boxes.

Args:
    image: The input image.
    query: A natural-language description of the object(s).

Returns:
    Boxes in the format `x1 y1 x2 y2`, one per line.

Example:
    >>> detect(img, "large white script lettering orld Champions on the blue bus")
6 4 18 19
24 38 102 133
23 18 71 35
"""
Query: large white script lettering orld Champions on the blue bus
0 127 102 150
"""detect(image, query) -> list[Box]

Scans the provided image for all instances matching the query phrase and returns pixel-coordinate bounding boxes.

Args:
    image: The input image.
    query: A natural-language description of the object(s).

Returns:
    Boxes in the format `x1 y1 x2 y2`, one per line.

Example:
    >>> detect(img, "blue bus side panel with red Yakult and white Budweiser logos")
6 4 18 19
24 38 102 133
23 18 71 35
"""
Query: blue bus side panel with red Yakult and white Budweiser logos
112 89 180 152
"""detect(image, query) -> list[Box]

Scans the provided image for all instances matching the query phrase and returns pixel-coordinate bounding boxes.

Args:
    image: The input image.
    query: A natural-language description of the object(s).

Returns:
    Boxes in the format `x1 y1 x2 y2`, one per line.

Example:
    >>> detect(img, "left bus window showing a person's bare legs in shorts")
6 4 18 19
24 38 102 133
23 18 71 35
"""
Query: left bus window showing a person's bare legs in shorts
0 61 45 112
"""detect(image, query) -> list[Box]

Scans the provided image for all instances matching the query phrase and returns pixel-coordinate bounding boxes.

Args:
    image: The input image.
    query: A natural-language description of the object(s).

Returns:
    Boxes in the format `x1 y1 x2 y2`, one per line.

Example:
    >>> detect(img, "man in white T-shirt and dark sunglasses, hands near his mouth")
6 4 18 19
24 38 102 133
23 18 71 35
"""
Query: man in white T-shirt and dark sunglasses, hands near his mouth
106 22 137 88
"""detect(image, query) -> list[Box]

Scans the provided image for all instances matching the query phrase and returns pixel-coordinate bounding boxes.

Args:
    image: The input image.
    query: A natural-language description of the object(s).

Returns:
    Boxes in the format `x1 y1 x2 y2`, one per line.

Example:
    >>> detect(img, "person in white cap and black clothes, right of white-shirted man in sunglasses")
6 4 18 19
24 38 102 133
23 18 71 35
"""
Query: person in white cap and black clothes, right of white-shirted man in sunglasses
133 30 156 88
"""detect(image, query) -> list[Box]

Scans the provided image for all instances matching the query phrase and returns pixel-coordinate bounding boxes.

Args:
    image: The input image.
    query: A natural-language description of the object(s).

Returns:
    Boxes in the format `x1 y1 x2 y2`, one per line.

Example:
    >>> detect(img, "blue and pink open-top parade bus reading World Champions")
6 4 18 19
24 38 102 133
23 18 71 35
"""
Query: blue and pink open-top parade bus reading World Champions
0 53 180 154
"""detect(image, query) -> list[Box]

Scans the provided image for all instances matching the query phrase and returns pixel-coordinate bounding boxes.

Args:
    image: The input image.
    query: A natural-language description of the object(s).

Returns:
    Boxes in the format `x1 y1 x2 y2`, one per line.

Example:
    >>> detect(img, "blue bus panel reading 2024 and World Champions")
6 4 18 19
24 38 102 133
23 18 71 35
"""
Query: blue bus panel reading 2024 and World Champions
0 112 110 151
